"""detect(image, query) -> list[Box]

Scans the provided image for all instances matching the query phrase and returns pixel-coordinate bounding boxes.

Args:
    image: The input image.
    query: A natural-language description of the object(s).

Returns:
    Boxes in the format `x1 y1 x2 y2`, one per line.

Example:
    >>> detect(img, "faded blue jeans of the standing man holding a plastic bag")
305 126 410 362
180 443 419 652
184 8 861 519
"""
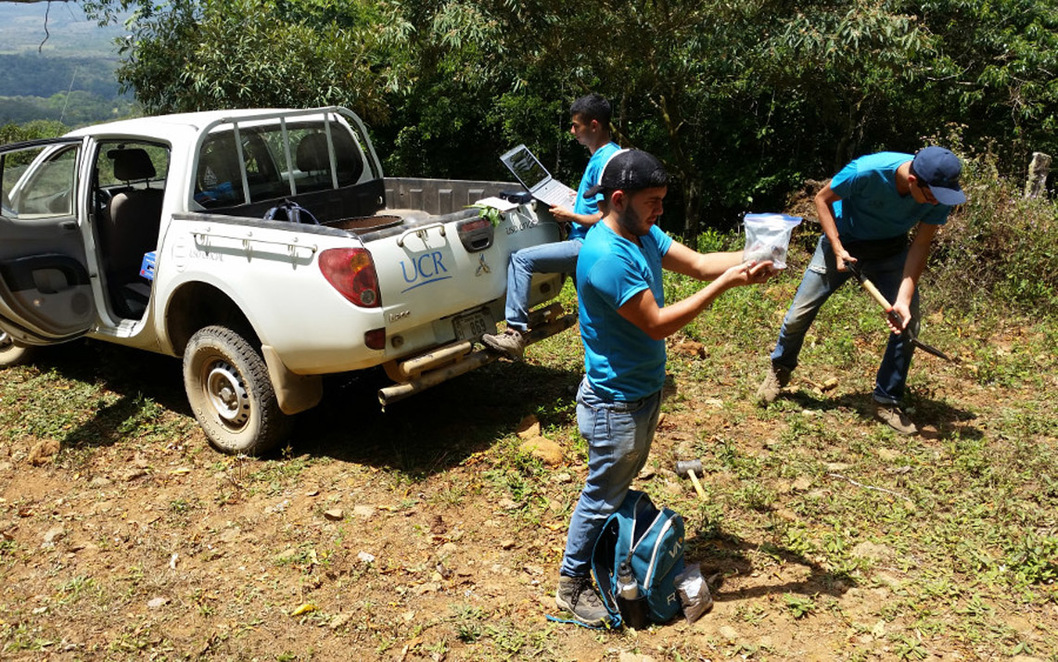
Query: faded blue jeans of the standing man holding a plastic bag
560 376 661 577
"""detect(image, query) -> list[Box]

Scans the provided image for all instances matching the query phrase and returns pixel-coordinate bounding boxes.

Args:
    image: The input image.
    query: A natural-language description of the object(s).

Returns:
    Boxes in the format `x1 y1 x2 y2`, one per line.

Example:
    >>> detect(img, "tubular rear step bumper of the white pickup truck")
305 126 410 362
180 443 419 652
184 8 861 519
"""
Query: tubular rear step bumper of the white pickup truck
379 304 577 403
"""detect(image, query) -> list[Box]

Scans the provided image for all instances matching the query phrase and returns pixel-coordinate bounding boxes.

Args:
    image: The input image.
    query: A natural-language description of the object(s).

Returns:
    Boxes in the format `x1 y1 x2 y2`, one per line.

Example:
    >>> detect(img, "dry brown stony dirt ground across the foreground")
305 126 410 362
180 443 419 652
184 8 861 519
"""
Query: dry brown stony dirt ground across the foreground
0 329 1058 662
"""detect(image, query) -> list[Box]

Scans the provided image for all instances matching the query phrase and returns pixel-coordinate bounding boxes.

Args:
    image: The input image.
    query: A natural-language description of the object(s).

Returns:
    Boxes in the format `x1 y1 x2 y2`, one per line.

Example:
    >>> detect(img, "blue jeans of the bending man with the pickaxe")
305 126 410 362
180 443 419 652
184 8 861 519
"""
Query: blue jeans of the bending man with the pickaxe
771 236 918 405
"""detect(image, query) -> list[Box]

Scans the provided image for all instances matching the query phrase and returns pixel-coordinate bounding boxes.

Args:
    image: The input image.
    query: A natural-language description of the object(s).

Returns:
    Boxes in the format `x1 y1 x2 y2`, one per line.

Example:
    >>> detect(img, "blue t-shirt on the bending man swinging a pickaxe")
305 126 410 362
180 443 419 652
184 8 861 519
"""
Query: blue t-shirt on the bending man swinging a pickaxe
831 151 951 240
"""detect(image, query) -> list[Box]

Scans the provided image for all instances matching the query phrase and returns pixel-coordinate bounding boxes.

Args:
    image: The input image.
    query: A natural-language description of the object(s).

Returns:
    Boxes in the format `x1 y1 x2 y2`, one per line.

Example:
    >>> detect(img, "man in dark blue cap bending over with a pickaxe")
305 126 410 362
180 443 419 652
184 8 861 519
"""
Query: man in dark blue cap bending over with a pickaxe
756 146 966 435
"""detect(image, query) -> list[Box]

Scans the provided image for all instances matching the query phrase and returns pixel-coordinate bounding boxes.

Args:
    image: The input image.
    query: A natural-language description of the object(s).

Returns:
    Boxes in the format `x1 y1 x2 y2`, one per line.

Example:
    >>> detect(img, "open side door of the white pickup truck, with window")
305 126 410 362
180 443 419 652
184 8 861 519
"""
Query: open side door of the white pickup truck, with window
0 139 95 346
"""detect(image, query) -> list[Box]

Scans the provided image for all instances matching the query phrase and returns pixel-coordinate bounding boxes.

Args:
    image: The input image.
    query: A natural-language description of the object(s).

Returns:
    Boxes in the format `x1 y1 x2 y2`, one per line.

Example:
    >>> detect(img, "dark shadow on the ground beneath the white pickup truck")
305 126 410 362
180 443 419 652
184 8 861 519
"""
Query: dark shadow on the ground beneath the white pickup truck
35 341 581 469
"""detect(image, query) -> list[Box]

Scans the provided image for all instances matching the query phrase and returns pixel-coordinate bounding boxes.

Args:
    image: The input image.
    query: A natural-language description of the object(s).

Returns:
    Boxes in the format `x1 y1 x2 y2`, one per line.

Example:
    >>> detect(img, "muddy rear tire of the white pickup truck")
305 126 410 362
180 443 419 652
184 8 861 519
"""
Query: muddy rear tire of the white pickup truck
184 326 293 456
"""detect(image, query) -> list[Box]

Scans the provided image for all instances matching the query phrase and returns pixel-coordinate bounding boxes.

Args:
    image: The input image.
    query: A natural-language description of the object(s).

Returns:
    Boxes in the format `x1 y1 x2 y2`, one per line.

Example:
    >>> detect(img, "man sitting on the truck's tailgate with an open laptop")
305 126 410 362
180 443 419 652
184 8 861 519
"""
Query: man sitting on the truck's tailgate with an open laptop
481 94 620 361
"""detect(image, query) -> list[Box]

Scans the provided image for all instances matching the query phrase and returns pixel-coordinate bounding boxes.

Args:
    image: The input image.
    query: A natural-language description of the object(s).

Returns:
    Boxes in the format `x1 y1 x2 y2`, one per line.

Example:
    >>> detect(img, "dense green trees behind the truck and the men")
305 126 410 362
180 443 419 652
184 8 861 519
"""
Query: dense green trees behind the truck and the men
6 0 1058 237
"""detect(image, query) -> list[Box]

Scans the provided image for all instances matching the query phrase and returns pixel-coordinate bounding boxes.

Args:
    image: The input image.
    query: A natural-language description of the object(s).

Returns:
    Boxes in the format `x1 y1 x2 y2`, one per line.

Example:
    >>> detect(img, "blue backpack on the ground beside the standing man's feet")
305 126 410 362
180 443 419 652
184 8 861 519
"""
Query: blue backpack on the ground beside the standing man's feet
591 490 683 627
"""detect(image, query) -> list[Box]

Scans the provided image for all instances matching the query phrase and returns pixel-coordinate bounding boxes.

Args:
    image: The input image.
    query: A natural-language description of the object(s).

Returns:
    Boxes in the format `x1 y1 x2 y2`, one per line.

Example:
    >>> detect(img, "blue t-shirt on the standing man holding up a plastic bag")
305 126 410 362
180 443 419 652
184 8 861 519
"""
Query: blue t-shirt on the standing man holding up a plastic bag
577 223 672 402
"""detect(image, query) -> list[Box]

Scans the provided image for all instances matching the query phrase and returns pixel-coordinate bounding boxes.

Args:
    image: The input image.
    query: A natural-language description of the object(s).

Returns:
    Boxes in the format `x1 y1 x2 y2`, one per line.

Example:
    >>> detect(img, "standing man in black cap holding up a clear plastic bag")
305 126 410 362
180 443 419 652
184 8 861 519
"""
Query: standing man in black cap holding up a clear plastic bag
555 150 772 625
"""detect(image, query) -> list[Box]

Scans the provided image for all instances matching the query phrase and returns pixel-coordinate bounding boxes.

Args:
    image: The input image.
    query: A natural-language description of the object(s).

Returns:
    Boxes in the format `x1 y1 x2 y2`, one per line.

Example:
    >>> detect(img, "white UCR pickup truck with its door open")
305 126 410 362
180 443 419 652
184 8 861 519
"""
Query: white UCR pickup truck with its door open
0 108 572 455
